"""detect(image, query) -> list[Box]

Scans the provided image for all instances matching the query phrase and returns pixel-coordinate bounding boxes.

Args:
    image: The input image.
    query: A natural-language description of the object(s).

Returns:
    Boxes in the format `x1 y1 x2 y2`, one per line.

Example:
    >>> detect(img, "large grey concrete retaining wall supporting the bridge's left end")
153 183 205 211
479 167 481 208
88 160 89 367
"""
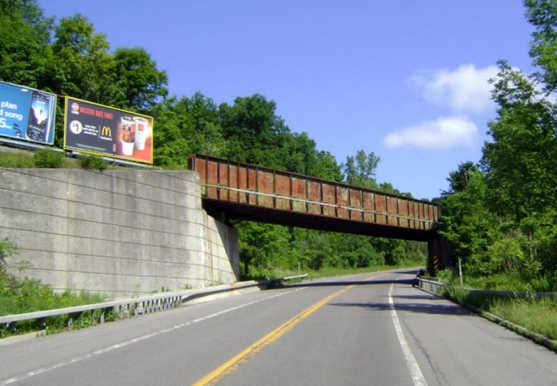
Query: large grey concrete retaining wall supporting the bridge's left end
0 169 239 298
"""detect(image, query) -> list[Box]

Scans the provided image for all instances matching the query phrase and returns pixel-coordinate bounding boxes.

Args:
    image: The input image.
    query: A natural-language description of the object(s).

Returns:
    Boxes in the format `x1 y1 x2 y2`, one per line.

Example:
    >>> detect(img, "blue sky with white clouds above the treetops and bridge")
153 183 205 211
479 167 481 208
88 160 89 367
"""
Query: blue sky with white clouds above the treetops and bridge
39 0 533 199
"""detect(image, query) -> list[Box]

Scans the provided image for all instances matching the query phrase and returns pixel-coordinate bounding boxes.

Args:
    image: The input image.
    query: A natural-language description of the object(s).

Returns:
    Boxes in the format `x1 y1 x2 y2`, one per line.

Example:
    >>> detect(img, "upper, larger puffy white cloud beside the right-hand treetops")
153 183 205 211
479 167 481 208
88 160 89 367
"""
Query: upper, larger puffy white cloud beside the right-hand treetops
408 64 499 113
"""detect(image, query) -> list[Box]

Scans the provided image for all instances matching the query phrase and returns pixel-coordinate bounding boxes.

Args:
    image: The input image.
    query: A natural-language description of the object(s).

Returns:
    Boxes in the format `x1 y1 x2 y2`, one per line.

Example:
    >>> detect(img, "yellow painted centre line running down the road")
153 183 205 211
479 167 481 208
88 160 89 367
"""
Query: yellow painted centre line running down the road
192 284 355 386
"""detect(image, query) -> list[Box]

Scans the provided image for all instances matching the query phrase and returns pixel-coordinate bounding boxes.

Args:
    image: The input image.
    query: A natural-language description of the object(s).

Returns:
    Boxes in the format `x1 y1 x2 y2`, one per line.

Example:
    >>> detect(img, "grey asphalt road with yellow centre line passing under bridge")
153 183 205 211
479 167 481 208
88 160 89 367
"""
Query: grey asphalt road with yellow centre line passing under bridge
0 272 557 386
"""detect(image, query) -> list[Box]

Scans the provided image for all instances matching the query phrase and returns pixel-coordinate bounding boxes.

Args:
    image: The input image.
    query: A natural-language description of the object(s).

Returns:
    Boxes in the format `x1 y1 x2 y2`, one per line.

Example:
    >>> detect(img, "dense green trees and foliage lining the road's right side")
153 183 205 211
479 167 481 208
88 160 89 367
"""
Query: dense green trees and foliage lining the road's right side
440 0 557 291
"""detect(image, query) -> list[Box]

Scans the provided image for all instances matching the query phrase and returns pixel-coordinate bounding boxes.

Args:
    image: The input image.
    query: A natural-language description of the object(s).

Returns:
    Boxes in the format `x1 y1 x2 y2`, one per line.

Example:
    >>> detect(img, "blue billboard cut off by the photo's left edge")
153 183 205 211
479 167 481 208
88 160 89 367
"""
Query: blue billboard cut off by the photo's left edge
0 82 56 145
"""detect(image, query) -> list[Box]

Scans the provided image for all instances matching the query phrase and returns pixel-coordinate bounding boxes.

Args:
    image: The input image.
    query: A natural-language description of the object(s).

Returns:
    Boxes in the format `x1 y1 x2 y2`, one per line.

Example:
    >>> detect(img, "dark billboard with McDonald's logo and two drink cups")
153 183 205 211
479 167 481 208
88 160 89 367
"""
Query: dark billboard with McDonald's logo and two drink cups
64 97 153 164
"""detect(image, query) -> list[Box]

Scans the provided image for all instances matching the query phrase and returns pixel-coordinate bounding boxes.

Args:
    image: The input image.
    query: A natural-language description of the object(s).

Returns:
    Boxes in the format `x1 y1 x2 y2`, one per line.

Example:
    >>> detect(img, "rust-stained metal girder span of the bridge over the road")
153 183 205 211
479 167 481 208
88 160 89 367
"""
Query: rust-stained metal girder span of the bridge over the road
188 154 440 241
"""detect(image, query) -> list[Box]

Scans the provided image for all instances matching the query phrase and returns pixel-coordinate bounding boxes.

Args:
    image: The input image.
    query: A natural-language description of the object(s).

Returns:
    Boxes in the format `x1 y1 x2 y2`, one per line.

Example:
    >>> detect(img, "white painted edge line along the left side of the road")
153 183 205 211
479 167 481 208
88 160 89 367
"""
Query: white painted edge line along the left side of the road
0 288 304 386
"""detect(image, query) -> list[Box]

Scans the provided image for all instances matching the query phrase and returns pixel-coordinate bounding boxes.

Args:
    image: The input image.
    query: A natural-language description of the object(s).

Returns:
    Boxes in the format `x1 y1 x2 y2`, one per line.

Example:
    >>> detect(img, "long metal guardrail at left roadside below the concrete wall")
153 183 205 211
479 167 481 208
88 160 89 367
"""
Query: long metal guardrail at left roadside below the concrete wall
0 274 307 329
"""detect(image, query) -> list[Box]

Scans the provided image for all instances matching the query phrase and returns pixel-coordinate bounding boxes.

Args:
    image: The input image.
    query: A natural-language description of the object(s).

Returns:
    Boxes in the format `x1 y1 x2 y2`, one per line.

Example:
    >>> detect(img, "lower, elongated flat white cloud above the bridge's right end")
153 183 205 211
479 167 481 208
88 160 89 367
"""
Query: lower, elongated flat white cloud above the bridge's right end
383 117 478 150
